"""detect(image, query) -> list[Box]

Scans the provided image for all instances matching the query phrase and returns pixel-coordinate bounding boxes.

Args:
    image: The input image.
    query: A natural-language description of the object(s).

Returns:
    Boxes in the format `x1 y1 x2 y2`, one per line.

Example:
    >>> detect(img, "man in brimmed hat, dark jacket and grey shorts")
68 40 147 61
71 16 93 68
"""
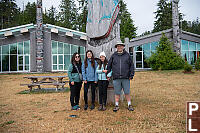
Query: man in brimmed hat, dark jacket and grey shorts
107 41 135 112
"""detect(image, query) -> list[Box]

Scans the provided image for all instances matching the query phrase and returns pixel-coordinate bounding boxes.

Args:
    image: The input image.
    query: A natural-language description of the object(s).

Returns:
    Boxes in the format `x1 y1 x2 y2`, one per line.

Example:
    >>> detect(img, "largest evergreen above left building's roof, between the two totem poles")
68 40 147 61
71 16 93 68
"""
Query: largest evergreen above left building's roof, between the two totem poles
56 0 78 30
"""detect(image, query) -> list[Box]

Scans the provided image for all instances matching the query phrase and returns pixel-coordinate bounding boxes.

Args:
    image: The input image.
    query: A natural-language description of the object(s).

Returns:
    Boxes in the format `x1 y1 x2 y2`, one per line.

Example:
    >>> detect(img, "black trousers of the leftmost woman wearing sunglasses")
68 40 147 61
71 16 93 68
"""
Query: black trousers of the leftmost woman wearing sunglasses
69 82 82 107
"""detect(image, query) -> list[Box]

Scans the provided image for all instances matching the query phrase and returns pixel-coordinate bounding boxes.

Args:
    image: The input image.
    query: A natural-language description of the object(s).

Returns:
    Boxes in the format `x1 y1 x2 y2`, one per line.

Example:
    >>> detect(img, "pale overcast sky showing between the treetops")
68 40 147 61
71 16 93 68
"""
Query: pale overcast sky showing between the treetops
16 0 200 35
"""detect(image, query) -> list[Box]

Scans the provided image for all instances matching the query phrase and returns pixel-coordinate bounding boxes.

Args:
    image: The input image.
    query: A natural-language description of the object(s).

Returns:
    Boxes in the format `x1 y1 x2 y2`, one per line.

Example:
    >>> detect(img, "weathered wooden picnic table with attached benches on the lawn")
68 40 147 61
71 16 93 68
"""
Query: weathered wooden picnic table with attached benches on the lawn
21 76 68 91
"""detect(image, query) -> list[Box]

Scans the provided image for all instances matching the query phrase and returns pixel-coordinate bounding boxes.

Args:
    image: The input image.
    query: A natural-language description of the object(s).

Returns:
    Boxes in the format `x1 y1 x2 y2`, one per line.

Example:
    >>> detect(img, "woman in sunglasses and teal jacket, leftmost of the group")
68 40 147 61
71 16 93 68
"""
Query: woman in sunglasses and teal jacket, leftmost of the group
68 52 82 110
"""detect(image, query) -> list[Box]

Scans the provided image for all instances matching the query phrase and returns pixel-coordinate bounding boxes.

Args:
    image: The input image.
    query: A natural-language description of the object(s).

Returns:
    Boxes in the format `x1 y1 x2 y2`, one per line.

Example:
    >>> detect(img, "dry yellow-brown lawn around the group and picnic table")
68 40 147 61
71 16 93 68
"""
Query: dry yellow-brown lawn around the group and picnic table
0 70 200 133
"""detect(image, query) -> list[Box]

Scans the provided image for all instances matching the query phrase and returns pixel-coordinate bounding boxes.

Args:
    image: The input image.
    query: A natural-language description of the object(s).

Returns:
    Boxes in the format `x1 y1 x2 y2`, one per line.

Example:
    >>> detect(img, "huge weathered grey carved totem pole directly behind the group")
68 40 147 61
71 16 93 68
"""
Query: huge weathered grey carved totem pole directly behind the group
86 0 120 103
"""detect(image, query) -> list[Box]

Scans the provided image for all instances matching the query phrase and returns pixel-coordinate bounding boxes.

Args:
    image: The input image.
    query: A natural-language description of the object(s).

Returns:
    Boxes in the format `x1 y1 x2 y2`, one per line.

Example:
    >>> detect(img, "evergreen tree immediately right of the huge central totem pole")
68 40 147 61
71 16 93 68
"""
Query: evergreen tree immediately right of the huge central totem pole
119 0 137 42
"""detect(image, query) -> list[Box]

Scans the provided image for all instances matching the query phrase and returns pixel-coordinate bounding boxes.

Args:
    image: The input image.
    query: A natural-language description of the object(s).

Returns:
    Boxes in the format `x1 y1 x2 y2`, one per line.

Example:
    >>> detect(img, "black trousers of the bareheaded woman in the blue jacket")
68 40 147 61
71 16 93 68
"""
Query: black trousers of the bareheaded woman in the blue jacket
84 81 96 104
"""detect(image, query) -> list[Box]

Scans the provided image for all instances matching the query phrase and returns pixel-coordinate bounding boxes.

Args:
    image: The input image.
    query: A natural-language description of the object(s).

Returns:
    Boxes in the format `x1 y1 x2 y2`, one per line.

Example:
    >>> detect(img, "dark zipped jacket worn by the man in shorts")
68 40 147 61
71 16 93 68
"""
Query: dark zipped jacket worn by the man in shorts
107 50 135 79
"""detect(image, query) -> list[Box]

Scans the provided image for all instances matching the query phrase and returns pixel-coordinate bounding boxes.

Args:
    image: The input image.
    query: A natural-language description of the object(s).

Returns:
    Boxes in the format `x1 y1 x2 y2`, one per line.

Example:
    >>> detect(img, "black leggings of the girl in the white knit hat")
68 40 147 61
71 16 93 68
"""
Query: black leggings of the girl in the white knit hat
98 80 109 105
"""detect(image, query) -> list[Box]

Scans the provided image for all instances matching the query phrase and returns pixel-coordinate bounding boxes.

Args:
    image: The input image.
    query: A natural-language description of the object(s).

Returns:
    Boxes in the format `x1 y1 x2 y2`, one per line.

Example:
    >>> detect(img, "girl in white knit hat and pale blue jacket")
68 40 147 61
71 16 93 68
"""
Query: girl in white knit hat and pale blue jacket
96 52 112 111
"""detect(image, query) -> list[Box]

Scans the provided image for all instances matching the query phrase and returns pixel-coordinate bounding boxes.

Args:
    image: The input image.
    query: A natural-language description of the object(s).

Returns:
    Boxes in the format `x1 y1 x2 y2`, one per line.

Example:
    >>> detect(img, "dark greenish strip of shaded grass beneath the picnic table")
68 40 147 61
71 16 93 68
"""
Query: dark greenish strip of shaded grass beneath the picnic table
17 87 70 94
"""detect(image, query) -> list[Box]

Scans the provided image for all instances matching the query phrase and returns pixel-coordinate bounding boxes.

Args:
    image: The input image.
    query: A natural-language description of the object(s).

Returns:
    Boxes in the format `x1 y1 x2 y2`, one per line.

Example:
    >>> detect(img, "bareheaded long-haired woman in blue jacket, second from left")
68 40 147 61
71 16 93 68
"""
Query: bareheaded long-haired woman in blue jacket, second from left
82 50 98 110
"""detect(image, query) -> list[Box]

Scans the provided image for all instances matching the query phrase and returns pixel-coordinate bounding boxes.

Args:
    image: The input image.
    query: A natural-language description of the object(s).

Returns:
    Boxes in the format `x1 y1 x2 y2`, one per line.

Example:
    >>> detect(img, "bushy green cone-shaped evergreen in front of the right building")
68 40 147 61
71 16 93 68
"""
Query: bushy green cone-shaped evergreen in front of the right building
146 33 184 70
